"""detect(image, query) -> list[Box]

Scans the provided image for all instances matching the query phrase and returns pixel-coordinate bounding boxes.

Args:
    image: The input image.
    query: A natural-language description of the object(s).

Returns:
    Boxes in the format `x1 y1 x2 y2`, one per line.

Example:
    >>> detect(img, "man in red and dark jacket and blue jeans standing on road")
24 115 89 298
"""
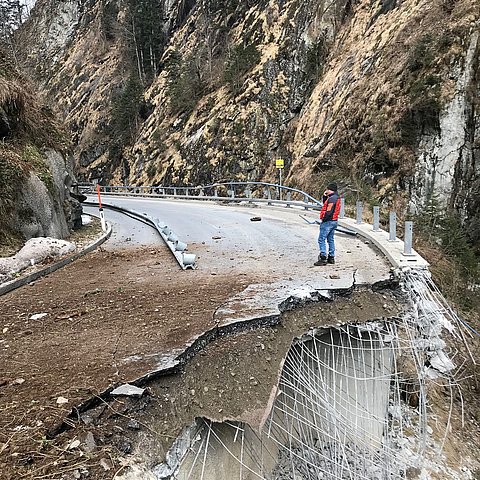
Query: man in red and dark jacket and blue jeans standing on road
314 182 340 267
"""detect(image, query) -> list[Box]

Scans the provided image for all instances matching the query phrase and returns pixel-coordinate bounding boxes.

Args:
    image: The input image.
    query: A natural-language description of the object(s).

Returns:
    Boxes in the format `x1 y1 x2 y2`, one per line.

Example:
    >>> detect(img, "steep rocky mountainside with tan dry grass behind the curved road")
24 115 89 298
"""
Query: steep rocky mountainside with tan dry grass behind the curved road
16 0 480 238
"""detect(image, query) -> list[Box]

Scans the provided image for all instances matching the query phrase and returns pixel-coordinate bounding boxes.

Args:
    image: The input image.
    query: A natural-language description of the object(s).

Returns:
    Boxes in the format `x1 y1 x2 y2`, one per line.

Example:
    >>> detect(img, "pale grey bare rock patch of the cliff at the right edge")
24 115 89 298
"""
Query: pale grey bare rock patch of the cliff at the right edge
413 30 480 243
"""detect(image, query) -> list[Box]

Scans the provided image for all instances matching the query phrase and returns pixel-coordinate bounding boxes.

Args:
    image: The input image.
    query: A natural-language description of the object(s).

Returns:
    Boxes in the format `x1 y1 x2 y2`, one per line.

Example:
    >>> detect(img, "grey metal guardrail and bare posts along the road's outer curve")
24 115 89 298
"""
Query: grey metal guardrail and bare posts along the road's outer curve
81 181 428 269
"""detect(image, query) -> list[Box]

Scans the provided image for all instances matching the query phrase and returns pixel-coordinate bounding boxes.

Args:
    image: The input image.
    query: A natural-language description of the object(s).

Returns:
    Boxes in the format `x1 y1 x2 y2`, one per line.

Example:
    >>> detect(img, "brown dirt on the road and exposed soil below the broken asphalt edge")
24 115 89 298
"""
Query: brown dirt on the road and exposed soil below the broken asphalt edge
0 222 478 480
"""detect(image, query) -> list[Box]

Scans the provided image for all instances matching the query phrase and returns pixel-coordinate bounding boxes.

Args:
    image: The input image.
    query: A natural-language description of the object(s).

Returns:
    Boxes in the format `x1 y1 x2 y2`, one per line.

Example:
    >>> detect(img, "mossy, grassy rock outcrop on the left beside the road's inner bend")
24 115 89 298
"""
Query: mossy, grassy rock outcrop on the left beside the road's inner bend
0 45 81 248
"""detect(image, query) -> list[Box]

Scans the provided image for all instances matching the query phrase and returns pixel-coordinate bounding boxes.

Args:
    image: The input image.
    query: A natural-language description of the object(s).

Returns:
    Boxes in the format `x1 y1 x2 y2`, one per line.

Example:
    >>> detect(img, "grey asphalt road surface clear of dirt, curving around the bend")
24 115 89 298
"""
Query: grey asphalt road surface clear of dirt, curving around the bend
85 197 390 322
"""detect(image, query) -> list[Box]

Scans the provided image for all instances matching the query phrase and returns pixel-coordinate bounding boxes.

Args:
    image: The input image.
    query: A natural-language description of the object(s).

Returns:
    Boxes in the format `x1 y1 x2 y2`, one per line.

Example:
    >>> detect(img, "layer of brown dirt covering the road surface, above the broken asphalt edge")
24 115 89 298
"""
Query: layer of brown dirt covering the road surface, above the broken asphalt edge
0 238 262 479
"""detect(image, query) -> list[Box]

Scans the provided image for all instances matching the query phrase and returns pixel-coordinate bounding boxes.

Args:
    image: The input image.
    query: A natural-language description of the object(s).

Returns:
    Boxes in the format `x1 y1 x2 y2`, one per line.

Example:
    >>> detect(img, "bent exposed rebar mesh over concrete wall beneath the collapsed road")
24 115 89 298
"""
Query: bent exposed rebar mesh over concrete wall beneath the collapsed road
169 271 464 480
